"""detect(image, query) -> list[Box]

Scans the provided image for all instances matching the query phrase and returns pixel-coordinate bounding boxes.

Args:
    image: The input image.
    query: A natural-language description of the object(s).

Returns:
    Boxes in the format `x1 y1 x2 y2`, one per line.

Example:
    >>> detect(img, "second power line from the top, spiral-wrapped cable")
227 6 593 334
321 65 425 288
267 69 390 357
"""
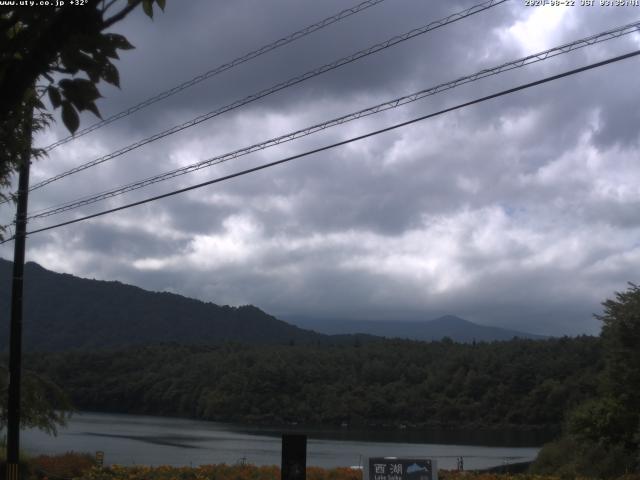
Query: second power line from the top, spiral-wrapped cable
30 0 508 194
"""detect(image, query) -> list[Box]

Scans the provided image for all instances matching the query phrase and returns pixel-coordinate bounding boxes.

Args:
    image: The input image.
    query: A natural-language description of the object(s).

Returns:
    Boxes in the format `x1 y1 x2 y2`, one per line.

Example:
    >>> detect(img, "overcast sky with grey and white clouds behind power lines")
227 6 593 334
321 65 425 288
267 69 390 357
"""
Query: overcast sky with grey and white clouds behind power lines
0 0 640 335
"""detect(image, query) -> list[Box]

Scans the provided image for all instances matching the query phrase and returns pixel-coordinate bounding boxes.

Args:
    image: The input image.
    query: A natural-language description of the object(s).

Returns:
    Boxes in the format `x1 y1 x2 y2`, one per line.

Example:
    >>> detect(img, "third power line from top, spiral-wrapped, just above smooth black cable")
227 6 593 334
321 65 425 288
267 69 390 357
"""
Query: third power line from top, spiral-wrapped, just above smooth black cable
23 21 640 219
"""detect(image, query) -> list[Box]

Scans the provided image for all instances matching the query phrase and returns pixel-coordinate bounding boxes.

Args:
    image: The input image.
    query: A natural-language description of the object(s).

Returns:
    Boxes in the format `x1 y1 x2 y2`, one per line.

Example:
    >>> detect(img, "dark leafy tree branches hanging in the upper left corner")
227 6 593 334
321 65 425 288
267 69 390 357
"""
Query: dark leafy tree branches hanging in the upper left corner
0 0 166 208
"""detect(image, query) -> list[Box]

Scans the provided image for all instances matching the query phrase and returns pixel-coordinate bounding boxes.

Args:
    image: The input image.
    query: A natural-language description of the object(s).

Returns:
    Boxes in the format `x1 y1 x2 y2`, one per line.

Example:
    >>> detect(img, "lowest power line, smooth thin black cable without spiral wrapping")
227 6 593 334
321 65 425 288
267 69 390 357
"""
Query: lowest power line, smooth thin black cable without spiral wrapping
1 50 640 243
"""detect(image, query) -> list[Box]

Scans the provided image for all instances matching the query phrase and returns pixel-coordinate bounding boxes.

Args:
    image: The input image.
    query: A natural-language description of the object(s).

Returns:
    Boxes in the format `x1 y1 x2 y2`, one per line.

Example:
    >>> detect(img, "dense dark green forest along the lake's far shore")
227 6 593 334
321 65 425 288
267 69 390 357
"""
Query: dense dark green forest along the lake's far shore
26 337 603 427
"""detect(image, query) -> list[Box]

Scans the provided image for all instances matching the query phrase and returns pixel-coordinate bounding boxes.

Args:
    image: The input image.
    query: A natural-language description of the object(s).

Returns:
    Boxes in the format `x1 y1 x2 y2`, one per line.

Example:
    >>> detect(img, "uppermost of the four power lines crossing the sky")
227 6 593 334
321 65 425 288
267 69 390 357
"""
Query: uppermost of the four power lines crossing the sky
44 0 385 152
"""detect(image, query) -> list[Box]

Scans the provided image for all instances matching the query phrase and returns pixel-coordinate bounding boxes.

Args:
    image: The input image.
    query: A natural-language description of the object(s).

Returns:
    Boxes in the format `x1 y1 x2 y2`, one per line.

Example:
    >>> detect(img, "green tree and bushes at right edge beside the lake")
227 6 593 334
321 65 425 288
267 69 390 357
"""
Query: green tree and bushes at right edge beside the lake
534 283 640 478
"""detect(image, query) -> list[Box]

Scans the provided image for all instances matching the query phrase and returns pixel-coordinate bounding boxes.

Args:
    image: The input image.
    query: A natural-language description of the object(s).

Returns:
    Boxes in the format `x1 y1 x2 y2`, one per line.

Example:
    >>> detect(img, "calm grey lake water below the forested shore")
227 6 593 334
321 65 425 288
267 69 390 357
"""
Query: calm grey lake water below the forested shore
21 413 541 469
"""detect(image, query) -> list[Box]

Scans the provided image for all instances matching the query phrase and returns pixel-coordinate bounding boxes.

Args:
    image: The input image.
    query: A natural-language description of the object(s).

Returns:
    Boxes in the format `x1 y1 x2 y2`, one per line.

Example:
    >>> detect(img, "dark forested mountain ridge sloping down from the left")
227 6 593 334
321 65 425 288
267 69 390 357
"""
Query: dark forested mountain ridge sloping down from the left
0 259 330 351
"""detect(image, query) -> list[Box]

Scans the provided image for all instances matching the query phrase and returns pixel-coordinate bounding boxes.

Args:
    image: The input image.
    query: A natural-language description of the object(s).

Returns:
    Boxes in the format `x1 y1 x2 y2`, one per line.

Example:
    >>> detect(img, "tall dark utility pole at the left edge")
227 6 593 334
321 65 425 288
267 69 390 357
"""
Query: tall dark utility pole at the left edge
6 109 33 480
